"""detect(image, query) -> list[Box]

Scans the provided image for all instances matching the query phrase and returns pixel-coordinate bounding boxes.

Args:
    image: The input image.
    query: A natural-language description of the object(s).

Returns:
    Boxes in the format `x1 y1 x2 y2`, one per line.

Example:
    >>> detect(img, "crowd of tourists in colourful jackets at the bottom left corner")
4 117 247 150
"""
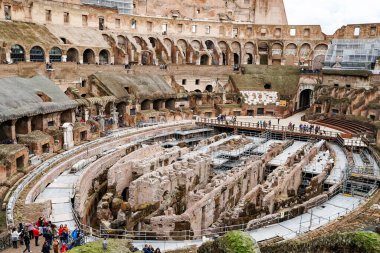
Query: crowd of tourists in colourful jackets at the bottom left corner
11 217 83 253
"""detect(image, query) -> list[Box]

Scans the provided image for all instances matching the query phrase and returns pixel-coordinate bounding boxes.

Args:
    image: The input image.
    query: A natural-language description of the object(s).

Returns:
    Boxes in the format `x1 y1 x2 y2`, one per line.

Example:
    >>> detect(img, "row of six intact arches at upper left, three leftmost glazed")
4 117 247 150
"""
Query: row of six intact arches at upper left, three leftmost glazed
10 44 110 64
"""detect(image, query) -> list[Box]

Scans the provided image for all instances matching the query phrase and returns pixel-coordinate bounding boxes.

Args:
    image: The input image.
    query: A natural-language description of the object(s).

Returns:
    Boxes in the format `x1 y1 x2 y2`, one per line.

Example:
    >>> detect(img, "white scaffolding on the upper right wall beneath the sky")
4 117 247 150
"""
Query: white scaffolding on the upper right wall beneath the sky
324 39 380 70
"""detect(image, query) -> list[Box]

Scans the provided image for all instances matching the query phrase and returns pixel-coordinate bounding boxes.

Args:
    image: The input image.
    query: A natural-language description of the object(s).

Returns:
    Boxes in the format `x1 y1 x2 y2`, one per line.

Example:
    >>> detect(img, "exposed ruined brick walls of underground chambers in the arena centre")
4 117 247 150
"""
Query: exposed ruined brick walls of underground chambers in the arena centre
79 130 346 239
